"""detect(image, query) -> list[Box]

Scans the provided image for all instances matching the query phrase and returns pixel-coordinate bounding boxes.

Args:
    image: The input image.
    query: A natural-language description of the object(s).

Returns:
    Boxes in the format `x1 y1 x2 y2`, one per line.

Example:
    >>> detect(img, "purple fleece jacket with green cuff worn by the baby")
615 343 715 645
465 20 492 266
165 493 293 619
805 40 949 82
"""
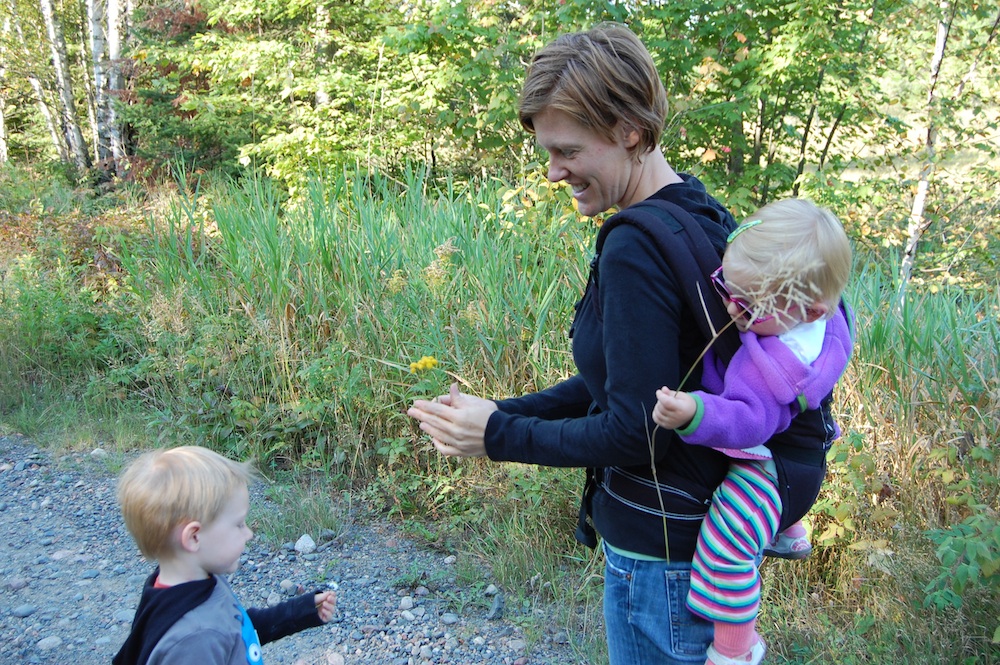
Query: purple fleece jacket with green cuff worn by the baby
677 308 852 449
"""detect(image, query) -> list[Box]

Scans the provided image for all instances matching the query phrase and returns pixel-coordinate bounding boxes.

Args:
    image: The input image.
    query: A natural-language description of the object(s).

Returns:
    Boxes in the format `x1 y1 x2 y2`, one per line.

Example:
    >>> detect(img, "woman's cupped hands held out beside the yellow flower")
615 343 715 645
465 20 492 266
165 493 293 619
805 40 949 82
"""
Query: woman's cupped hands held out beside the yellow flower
406 383 497 457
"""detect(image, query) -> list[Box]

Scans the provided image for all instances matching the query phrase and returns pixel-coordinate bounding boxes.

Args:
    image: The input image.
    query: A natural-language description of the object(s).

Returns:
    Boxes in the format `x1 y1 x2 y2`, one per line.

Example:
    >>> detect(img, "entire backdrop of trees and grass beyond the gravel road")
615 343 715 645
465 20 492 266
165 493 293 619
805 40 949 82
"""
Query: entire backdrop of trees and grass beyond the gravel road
0 0 1000 664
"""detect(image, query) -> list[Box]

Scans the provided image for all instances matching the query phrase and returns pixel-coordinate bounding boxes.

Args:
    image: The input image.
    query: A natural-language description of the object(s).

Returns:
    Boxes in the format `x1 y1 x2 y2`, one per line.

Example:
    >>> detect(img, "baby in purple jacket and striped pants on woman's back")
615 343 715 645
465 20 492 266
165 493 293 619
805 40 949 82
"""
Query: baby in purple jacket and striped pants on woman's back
653 199 853 665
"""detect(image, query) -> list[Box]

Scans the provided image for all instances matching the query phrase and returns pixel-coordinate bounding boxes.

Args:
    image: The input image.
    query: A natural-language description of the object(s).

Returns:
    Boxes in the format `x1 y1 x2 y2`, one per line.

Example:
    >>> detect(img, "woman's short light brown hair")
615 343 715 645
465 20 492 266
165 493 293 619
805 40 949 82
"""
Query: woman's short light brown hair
518 23 667 158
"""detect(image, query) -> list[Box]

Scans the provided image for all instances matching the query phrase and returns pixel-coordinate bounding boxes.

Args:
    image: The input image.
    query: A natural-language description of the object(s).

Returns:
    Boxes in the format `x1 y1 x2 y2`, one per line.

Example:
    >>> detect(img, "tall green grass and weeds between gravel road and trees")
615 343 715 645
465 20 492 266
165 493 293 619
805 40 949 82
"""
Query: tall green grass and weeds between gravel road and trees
0 162 1000 665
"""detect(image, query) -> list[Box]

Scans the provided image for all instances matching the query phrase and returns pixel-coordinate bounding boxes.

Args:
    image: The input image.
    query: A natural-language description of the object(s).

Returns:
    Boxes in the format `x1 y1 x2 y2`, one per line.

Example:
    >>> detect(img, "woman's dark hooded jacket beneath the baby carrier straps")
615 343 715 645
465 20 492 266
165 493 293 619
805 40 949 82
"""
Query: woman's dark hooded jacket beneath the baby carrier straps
485 175 736 561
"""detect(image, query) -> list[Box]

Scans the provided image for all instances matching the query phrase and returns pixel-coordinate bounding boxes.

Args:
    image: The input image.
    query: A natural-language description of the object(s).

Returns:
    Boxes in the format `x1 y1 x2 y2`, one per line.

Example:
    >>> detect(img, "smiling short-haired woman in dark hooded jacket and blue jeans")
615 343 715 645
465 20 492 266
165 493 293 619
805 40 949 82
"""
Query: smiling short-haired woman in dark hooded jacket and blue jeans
408 25 736 665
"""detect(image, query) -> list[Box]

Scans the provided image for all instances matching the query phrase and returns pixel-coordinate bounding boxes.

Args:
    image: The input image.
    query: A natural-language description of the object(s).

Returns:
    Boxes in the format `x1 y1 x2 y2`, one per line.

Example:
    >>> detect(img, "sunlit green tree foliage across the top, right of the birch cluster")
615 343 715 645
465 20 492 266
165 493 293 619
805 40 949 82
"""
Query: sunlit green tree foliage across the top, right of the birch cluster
94 0 1000 226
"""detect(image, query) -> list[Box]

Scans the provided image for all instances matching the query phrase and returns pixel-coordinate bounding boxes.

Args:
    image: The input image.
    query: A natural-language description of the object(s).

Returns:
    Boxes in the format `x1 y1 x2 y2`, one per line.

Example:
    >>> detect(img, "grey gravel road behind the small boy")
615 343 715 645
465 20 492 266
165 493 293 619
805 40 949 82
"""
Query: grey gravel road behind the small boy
0 435 585 665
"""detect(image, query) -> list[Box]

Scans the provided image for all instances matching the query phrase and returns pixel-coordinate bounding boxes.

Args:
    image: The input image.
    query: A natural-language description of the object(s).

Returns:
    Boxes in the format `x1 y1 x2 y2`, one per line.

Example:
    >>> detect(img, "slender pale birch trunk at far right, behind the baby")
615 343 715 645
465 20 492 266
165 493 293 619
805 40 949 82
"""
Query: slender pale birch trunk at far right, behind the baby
897 0 955 298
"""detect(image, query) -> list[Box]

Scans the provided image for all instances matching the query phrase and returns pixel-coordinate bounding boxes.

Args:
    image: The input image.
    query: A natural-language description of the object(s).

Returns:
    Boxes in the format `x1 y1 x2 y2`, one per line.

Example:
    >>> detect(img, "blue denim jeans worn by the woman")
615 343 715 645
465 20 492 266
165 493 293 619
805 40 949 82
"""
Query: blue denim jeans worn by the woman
604 547 713 665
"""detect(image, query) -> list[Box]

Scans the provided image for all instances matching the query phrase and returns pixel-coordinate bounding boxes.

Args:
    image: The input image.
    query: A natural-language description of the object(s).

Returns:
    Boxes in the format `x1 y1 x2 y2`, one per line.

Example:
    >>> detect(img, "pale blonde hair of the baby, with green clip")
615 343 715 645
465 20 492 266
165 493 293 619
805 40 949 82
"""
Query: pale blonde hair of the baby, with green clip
725 199 851 316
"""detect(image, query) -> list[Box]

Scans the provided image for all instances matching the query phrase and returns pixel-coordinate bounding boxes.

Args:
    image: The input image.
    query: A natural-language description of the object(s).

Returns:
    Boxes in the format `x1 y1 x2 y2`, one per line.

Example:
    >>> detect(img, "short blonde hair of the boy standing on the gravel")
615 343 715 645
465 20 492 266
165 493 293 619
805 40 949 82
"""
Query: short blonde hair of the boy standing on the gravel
118 446 254 559
